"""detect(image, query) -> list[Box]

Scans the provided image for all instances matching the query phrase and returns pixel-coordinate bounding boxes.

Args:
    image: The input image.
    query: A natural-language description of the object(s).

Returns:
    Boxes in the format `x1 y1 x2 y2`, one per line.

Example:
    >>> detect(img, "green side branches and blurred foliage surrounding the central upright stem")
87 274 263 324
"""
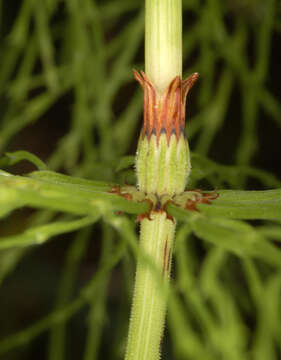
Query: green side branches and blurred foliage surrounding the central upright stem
0 0 281 360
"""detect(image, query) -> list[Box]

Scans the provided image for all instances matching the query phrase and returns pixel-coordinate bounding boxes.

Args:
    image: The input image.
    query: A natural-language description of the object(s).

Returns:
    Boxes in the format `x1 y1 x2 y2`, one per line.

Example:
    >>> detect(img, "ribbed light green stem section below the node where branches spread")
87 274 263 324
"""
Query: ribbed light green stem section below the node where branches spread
125 212 175 360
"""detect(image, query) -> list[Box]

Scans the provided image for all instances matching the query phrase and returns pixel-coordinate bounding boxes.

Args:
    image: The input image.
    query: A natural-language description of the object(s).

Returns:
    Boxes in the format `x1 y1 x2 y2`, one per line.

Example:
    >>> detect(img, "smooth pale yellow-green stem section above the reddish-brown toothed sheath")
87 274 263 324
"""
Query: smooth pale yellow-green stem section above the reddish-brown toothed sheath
145 0 182 93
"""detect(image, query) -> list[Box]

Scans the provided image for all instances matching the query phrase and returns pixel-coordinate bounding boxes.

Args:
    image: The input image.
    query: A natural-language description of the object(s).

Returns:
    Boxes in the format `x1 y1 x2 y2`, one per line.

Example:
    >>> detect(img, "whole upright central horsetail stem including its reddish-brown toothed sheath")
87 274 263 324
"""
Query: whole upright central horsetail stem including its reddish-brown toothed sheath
125 0 202 360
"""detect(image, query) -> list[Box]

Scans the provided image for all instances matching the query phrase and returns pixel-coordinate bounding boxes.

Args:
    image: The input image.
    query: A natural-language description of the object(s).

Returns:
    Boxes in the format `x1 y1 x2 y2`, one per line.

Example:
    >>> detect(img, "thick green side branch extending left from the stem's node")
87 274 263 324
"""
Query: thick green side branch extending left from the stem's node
0 171 149 216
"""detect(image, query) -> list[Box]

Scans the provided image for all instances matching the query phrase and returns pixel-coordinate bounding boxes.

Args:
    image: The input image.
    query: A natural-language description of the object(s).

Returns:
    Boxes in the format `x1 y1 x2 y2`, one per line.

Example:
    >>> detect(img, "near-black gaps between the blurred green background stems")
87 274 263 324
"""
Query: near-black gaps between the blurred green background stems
0 0 281 360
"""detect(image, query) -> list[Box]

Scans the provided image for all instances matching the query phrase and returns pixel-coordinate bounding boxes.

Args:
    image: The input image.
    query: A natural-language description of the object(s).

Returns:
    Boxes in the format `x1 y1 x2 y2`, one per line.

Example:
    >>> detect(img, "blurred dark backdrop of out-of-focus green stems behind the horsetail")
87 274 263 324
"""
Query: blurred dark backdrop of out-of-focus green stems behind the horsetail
0 0 281 360
